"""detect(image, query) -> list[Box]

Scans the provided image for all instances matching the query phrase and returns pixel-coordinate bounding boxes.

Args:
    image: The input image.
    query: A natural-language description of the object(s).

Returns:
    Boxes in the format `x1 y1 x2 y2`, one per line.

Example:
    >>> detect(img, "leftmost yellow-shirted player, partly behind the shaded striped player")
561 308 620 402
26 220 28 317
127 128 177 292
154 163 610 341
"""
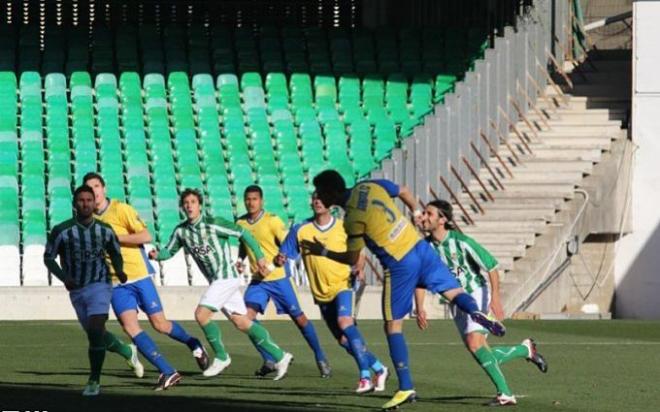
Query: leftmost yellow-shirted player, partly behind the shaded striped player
83 173 209 390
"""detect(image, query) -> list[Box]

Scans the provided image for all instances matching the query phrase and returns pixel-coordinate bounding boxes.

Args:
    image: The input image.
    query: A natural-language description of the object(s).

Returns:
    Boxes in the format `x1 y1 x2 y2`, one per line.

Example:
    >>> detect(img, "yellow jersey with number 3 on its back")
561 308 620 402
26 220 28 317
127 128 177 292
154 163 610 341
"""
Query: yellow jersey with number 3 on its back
342 179 421 267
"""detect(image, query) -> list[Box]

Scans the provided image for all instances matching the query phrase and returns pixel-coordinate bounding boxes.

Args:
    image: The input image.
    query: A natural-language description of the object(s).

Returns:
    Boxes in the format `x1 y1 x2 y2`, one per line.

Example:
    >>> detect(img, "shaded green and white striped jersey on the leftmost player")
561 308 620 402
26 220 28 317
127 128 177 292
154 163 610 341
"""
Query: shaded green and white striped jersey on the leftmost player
44 218 123 287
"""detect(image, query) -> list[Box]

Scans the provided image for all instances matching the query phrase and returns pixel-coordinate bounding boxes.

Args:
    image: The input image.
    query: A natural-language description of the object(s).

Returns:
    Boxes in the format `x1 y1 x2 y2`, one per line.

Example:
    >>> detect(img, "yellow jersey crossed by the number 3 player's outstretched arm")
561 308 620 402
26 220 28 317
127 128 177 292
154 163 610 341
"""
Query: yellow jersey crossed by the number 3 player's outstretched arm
280 217 351 303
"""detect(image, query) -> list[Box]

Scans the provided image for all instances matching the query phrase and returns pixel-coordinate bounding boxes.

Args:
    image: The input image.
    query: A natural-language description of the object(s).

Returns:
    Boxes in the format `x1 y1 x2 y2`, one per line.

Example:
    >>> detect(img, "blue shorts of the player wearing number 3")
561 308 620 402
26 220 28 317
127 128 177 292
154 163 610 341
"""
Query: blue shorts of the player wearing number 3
382 240 461 320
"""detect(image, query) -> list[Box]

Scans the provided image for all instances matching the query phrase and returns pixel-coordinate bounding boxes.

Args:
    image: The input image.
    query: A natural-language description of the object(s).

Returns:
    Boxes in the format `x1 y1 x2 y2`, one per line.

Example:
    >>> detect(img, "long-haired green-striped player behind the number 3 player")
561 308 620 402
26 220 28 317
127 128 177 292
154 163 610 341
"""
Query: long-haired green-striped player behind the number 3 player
415 200 548 406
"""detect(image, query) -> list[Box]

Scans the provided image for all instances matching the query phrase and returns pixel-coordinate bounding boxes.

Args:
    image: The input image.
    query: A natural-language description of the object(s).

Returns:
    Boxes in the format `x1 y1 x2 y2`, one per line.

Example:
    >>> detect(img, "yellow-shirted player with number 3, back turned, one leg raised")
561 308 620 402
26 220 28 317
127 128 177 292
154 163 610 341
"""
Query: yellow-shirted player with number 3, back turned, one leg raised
301 170 505 409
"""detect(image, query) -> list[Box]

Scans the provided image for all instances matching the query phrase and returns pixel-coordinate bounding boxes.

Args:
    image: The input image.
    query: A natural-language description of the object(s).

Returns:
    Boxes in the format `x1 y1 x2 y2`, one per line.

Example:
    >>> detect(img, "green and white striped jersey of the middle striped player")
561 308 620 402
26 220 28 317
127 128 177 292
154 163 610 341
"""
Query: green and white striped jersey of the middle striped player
156 216 264 283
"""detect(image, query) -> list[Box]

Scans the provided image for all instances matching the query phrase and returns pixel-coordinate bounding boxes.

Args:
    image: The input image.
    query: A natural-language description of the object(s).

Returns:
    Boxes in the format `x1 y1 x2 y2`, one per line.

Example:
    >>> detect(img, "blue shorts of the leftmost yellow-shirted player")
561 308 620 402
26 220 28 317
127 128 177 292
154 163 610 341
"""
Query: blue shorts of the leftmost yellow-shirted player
112 276 163 317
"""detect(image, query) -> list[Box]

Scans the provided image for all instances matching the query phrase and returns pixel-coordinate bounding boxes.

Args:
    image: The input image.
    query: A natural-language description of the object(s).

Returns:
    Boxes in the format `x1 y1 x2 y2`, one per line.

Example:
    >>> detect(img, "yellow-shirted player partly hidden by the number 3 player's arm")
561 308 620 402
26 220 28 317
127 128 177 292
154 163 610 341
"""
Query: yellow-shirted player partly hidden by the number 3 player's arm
276 193 388 394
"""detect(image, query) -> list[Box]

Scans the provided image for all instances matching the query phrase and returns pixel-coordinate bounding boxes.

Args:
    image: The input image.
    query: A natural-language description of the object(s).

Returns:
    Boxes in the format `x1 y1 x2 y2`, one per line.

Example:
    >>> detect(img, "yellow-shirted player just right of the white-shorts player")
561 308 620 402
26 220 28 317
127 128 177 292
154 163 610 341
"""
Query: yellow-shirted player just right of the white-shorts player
236 185 331 378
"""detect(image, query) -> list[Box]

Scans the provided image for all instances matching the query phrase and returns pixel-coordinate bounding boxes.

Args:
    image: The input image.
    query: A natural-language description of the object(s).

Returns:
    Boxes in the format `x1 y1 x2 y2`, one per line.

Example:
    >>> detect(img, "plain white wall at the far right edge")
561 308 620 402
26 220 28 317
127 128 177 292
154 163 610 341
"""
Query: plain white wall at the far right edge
615 0 660 319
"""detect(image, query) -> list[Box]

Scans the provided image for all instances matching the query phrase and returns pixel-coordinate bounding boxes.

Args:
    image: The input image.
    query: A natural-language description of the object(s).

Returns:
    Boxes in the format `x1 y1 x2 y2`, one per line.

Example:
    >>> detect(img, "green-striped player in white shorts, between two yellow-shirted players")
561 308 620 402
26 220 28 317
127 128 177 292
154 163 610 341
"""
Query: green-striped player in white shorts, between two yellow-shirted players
149 189 293 380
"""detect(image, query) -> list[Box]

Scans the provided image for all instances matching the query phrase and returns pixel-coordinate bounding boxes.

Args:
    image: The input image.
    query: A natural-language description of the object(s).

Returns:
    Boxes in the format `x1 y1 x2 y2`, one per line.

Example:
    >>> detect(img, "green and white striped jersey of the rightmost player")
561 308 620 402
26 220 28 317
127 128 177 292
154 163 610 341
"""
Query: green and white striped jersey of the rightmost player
426 230 497 293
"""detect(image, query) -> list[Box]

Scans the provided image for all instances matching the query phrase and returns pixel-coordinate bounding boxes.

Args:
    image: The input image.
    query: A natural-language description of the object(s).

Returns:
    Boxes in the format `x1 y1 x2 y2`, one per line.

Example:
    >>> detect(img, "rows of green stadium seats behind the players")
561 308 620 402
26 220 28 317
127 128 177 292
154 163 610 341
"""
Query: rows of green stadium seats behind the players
0 24 487 284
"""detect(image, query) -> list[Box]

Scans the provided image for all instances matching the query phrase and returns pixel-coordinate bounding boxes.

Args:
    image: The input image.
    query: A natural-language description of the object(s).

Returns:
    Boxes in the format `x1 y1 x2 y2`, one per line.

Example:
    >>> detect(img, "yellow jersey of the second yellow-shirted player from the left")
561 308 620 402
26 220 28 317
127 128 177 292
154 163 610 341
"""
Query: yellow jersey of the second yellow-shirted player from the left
236 211 286 282
